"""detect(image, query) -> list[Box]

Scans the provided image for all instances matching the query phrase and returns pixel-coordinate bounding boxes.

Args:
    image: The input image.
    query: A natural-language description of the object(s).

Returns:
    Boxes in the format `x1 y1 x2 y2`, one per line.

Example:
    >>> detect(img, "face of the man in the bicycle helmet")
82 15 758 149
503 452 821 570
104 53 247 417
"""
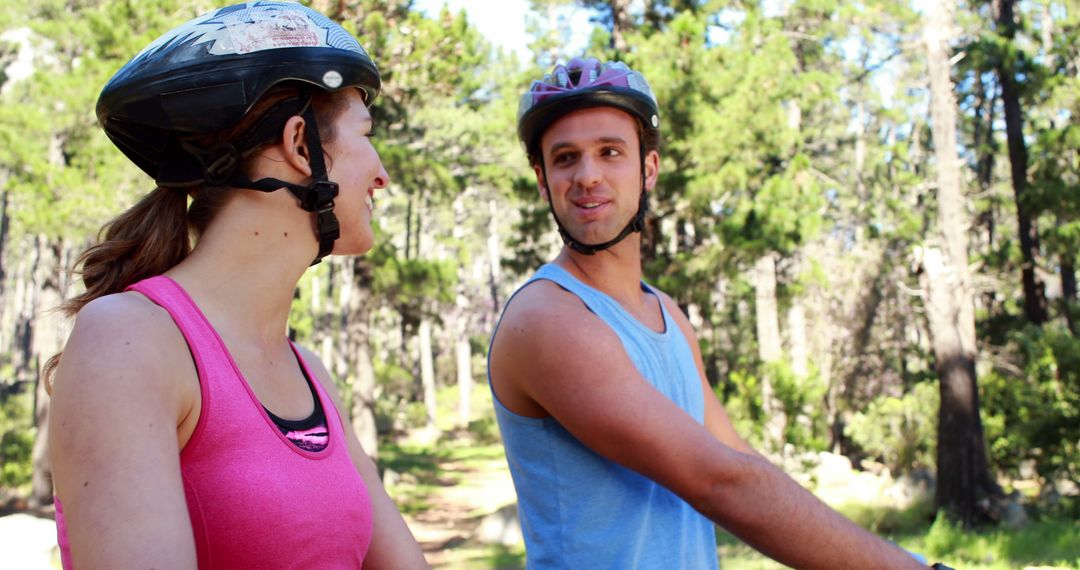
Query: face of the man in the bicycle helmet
535 107 659 244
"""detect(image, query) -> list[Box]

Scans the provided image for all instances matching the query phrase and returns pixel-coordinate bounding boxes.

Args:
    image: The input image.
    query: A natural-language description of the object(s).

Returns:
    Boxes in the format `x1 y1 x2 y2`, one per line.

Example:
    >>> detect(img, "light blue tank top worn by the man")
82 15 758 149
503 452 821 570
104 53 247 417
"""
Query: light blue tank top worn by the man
488 263 717 570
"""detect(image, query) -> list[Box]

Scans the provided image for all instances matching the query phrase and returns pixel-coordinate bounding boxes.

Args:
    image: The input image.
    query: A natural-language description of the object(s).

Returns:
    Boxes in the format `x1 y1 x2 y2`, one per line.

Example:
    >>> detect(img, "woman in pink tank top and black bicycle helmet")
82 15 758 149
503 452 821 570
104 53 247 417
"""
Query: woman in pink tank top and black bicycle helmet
50 2 427 569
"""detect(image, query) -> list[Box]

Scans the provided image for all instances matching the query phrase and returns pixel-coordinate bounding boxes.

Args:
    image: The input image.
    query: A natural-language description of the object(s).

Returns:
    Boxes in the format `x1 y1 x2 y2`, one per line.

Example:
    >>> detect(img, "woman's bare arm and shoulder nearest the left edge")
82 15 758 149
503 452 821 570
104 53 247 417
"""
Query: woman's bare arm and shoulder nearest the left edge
49 294 199 569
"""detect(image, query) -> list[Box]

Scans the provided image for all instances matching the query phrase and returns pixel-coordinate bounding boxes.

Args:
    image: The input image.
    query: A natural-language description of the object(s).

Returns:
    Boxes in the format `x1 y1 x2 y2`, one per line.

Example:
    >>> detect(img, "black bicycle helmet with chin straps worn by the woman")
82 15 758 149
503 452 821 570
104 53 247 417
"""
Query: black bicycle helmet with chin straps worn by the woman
97 1 381 262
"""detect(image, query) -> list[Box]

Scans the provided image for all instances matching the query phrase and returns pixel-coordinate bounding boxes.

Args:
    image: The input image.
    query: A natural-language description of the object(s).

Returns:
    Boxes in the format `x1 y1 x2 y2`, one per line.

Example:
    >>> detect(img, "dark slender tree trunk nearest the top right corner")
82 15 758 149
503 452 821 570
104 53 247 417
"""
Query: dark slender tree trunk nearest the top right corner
998 0 1048 326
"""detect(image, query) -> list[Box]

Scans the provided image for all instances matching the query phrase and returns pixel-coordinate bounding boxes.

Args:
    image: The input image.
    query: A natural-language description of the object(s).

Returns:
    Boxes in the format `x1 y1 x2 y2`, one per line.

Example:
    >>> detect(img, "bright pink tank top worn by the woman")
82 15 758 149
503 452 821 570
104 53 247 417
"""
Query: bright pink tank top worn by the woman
56 275 372 570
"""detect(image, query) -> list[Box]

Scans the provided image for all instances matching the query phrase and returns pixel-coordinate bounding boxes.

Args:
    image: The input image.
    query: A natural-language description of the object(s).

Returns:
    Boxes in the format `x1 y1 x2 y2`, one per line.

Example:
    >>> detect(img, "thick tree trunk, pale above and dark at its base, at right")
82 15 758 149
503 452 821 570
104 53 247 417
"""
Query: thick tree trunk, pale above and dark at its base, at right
921 0 997 526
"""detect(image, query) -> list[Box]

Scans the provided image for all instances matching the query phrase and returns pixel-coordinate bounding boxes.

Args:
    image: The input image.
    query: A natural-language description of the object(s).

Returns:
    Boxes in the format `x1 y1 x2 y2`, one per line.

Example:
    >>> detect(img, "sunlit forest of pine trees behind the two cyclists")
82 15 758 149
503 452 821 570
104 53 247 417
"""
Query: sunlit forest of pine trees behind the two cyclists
0 0 1080 568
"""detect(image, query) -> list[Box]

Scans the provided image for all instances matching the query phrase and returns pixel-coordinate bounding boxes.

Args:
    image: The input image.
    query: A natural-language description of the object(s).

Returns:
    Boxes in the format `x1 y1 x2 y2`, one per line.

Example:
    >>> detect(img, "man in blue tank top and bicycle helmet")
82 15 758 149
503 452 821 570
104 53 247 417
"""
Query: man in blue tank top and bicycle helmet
489 58 937 570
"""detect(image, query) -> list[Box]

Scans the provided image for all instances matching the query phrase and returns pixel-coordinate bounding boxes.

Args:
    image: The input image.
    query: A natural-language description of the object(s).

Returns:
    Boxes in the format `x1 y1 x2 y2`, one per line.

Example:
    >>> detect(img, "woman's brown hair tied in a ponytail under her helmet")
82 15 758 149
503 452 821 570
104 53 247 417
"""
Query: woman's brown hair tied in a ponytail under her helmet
42 84 347 390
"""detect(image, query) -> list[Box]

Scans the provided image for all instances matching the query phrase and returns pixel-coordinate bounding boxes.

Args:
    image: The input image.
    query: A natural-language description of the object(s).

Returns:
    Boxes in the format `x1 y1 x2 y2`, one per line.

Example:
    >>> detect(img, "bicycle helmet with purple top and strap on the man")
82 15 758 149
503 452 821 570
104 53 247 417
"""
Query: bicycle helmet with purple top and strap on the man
517 57 660 255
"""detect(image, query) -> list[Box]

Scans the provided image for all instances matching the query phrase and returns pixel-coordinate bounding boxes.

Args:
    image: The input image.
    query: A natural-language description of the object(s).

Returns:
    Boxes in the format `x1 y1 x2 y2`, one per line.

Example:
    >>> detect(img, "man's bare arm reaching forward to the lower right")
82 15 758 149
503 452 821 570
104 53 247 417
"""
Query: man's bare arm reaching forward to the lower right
491 283 921 568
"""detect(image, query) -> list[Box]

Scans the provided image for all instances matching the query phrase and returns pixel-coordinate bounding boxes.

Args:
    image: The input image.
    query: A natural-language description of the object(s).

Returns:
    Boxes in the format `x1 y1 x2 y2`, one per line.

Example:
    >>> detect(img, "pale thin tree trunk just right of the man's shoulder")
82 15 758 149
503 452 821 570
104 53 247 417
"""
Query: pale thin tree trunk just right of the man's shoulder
754 253 786 446
